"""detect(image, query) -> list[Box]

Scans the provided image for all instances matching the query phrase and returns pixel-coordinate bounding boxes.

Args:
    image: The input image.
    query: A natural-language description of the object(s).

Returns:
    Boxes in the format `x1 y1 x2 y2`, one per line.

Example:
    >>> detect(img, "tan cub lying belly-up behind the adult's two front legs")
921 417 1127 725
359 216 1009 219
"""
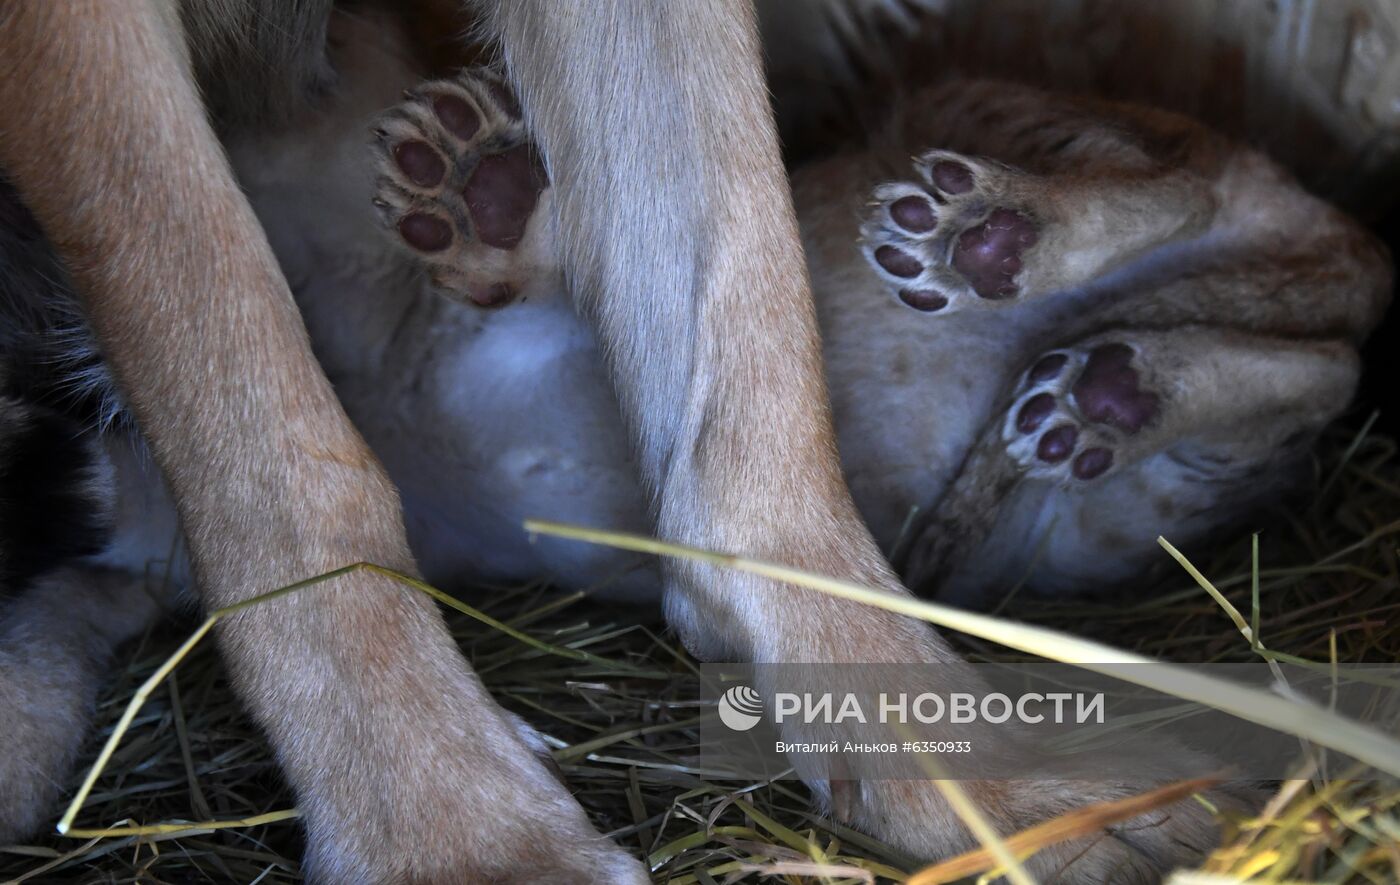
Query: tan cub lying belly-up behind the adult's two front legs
338 70 1390 604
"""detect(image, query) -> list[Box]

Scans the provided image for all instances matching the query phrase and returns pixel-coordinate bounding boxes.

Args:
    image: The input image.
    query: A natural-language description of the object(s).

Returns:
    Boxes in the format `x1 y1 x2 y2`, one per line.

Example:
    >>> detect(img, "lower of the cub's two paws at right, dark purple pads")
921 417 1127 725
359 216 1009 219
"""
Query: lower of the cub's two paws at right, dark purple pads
1002 342 1162 480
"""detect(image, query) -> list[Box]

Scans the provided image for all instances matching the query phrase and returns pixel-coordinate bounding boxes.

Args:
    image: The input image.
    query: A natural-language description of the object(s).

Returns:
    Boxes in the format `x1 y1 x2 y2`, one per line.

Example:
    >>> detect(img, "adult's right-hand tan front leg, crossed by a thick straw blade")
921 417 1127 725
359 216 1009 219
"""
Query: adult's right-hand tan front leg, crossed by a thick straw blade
487 0 1237 882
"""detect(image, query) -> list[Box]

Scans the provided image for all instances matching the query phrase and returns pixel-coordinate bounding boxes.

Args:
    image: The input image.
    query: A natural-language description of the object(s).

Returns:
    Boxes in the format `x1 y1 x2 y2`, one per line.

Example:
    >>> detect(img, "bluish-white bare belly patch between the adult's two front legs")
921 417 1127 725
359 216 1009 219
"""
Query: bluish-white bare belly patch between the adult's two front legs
397 300 655 595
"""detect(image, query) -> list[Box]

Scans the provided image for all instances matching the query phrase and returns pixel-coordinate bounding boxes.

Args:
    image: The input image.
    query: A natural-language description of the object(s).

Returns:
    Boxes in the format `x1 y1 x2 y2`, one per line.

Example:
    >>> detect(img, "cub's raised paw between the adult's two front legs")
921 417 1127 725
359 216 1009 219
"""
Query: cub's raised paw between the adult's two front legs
374 67 553 307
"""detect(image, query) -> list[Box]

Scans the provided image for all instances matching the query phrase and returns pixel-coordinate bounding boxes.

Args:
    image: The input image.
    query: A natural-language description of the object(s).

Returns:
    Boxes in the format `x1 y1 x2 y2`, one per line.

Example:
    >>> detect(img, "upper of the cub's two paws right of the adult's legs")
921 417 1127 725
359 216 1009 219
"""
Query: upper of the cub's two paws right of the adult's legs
861 151 1040 312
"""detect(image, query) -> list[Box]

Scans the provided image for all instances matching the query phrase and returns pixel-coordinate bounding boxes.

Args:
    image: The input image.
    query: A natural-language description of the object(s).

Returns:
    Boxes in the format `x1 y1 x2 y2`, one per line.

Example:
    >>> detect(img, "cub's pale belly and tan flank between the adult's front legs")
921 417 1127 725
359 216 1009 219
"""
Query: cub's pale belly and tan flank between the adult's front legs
301 284 658 598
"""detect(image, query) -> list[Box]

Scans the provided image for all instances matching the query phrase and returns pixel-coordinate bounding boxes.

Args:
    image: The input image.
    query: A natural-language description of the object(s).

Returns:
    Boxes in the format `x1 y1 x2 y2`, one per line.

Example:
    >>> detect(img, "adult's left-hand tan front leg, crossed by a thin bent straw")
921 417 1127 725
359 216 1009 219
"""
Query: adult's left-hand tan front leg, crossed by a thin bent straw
0 0 644 882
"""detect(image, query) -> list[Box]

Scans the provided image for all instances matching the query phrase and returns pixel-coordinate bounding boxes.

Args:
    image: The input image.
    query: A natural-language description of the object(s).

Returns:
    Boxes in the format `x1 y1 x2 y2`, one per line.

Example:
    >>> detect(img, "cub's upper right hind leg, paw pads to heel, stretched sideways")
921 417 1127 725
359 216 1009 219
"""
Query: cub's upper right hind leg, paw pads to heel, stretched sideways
861 150 1215 311
